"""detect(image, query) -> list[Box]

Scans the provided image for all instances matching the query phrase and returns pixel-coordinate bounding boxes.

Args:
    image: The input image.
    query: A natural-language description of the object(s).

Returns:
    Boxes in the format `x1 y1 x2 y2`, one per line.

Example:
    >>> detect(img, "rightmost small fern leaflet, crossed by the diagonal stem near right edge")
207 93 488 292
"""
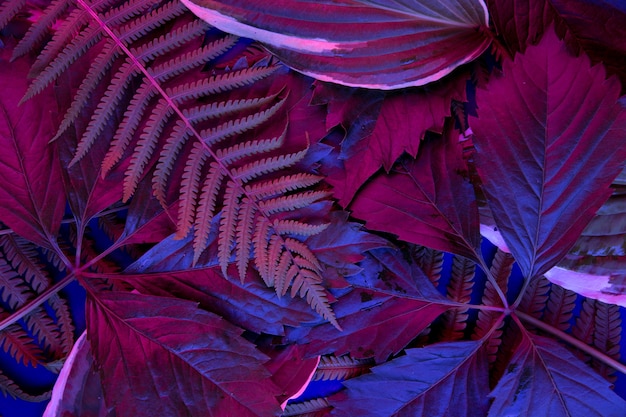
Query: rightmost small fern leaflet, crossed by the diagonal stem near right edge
592 301 622 382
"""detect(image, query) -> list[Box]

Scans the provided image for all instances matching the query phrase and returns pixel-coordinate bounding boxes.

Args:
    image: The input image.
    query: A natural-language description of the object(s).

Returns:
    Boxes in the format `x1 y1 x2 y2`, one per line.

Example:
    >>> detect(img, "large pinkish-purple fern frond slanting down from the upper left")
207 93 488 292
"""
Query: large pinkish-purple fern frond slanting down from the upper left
17 0 337 325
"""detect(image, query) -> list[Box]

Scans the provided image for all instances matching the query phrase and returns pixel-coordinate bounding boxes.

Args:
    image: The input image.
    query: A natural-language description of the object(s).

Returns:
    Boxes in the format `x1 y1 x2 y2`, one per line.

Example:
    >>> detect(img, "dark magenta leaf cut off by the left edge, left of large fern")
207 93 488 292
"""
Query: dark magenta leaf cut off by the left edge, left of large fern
0 48 65 247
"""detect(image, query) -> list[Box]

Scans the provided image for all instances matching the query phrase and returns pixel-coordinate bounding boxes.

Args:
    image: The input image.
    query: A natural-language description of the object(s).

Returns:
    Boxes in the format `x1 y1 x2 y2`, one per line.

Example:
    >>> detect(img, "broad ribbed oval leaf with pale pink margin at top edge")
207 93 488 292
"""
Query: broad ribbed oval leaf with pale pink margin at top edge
182 0 491 90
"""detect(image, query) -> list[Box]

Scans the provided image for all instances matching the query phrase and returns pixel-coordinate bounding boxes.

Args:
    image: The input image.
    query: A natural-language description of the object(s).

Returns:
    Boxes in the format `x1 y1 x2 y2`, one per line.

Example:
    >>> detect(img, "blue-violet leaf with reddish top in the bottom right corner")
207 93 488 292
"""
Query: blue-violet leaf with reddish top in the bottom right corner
489 333 626 417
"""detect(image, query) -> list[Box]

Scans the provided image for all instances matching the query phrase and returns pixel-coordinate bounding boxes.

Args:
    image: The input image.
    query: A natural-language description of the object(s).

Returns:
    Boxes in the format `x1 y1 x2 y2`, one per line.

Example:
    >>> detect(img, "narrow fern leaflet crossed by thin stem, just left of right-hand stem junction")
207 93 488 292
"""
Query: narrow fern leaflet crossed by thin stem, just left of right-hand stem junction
441 256 476 340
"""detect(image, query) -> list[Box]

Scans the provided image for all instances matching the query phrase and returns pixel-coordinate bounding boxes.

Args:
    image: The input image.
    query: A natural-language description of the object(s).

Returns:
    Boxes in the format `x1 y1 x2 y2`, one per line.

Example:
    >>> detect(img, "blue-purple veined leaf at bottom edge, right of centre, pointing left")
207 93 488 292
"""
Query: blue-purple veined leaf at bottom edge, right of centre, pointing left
330 341 490 417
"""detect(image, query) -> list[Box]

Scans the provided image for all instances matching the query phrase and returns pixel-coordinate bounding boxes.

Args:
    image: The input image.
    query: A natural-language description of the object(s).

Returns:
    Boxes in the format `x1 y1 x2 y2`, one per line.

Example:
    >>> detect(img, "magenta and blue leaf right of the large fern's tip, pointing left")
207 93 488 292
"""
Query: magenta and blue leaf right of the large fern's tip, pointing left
287 249 452 362
